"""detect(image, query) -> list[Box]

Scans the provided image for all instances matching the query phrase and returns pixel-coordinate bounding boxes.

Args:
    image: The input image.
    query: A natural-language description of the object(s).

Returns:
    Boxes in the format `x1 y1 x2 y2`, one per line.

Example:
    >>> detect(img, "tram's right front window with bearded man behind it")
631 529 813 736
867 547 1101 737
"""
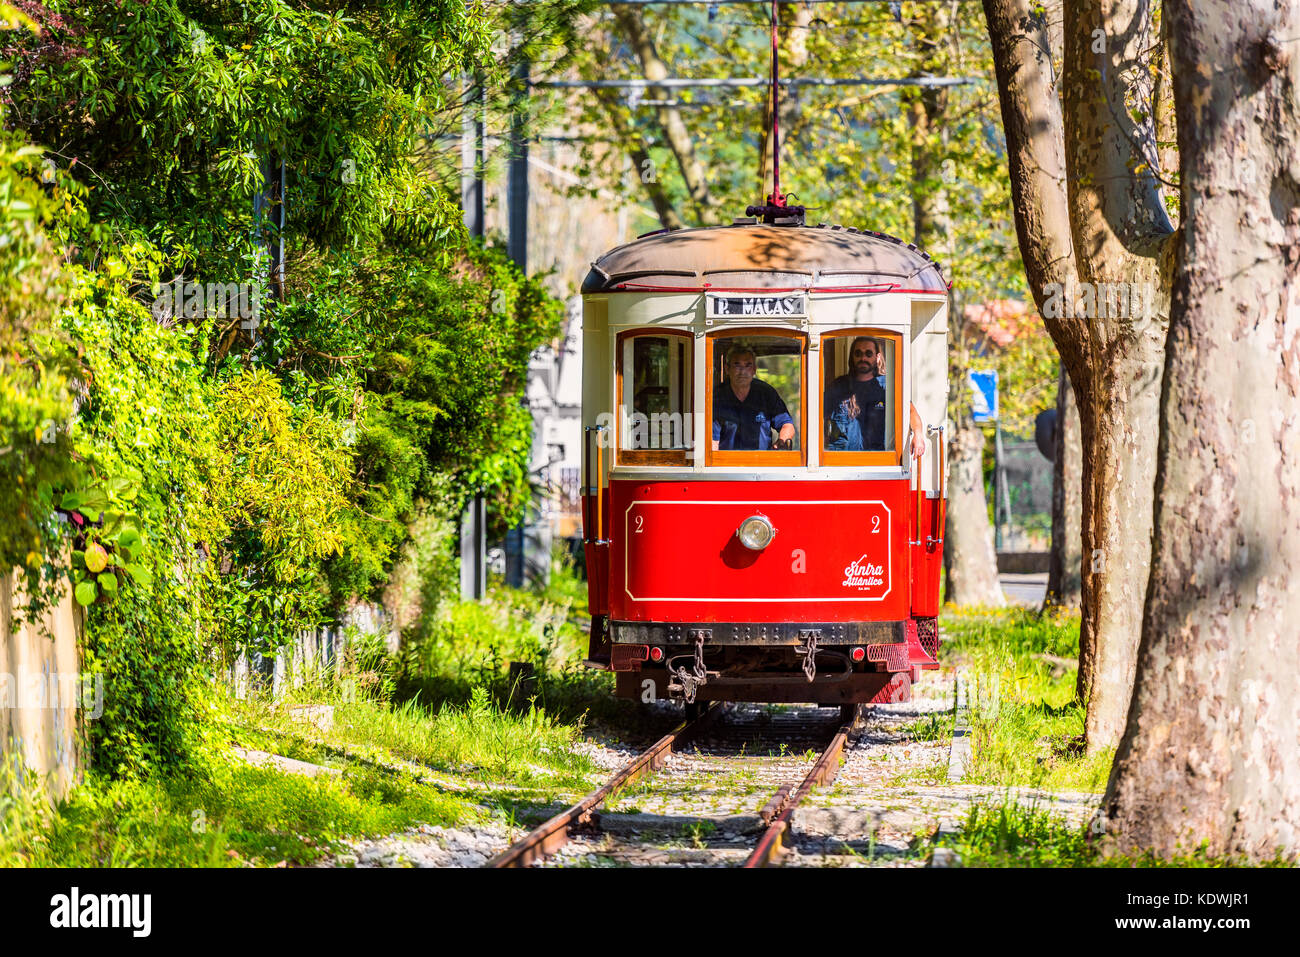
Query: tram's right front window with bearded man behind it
822 332 901 464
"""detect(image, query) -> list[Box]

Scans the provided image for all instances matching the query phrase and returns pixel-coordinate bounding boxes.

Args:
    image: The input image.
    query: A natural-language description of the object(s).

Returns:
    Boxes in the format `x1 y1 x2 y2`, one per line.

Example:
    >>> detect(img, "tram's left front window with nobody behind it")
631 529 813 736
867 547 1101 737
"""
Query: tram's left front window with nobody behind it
619 334 692 452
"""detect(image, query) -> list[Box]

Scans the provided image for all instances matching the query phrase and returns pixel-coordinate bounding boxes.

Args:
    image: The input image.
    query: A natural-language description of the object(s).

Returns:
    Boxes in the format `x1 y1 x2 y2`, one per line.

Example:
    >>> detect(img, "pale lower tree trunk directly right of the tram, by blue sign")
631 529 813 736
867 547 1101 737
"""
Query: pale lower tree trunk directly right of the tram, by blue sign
944 421 1006 607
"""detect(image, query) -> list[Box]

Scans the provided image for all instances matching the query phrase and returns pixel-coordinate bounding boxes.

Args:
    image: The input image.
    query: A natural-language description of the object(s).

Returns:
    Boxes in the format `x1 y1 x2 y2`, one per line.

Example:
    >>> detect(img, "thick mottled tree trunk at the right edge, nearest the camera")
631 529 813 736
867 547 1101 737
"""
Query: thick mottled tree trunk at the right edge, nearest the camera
1106 0 1300 859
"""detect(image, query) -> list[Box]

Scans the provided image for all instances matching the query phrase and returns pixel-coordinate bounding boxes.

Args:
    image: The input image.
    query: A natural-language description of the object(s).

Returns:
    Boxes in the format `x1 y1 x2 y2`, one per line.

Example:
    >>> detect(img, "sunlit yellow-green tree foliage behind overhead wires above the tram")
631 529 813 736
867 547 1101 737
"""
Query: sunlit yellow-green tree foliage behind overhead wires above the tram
569 4 1024 302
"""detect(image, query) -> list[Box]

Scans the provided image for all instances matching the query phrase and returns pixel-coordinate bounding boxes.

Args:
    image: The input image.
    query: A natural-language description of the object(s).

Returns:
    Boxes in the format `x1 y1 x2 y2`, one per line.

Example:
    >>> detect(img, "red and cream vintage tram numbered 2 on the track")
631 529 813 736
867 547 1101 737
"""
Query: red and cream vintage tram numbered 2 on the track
582 217 948 709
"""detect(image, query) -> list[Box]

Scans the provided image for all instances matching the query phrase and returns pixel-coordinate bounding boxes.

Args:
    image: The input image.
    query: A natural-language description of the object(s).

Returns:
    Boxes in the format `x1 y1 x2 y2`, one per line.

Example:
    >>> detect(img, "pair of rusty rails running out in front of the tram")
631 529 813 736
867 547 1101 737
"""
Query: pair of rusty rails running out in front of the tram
486 705 861 867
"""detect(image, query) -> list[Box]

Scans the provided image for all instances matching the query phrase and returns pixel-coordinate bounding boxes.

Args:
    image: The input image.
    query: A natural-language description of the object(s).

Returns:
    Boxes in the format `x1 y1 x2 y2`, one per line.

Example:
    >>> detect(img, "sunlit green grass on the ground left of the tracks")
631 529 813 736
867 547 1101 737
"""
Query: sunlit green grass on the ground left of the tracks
0 553 618 867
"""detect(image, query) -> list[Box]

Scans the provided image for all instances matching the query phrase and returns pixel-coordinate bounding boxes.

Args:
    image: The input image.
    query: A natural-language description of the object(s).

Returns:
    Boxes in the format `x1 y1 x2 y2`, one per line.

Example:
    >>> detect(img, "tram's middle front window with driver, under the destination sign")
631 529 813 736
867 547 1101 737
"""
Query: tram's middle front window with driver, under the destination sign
709 333 805 464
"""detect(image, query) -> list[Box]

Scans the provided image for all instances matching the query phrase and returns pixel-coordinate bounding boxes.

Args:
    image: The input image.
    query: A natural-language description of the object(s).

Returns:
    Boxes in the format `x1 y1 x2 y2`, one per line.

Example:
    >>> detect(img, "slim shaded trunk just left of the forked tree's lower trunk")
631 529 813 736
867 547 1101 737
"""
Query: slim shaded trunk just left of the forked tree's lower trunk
1044 367 1083 609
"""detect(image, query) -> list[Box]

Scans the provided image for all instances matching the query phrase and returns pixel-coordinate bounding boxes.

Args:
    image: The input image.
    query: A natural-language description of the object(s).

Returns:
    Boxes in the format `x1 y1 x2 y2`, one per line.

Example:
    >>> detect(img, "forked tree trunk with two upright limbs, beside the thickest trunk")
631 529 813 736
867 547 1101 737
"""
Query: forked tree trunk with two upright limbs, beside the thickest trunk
984 0 1173 752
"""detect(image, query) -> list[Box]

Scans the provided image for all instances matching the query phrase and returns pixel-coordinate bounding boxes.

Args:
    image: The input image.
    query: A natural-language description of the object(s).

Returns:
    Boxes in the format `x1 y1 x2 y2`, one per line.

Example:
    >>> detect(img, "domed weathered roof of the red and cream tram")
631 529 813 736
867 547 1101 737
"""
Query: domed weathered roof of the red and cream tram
582 224 948 295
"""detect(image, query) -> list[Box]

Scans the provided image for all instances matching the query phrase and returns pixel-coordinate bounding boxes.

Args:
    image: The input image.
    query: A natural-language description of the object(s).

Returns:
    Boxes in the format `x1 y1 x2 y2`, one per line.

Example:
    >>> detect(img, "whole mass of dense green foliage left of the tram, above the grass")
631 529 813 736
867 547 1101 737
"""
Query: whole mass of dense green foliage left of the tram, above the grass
0 0 569 778
